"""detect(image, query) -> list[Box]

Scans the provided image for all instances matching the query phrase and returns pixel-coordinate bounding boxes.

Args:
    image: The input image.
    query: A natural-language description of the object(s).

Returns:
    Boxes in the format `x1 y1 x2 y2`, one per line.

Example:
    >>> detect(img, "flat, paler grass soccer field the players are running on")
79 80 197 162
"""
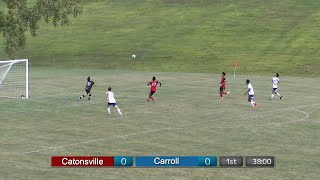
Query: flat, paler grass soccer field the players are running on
0 67 320 179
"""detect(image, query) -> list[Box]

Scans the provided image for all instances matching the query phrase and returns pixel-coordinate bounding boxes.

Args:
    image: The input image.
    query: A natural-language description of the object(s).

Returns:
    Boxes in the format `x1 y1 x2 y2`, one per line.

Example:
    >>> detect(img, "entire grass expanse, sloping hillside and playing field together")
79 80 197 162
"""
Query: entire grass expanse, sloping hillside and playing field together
0 0 320 179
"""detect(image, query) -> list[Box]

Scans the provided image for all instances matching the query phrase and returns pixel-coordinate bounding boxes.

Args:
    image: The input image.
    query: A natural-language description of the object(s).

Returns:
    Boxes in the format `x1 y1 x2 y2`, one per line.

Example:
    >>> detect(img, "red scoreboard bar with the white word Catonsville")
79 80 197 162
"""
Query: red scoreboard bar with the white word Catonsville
51 156 114 167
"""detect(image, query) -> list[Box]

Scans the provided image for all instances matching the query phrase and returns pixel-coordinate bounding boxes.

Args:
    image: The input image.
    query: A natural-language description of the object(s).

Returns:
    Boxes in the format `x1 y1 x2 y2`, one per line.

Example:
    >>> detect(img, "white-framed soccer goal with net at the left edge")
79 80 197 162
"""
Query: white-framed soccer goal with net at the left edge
0 59 29 99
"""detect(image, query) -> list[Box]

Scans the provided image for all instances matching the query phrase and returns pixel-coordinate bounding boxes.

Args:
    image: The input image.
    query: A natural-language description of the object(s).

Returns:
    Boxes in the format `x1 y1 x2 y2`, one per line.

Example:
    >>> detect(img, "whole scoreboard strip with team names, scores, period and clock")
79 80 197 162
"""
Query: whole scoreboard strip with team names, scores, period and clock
51 156 275 168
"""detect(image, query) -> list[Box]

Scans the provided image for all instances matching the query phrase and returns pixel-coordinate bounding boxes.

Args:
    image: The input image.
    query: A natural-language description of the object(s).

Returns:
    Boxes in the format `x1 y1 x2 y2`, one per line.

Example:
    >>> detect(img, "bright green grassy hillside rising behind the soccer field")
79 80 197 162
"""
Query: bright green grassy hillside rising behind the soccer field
0 0 320 76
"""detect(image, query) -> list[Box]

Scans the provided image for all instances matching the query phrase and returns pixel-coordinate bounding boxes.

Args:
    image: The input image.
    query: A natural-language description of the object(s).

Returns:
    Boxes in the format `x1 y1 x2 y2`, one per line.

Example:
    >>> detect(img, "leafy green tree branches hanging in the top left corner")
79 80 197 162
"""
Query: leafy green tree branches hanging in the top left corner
0 0 82 57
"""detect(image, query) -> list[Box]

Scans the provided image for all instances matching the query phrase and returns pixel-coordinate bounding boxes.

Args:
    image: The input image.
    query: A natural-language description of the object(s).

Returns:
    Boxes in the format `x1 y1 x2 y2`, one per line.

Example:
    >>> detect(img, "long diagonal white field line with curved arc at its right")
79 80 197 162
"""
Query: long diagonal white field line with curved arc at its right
12 103 320 155
